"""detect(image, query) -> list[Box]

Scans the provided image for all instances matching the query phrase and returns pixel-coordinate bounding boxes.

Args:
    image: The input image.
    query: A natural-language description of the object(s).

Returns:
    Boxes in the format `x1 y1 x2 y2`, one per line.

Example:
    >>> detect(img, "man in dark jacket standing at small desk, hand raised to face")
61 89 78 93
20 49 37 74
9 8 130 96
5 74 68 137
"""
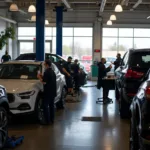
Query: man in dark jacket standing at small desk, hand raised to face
97 58 112 102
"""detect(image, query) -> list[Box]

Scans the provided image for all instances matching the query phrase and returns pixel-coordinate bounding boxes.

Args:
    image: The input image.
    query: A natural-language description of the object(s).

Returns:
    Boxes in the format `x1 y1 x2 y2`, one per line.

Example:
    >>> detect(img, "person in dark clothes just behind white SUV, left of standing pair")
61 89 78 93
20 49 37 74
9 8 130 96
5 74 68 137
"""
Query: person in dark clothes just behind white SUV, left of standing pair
62 56 74 96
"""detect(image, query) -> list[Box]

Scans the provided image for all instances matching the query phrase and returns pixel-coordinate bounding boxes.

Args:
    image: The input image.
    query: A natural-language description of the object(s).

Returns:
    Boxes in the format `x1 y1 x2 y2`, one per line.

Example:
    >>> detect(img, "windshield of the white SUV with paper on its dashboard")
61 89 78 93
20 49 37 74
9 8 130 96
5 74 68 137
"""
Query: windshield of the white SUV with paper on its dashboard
0 64 40 79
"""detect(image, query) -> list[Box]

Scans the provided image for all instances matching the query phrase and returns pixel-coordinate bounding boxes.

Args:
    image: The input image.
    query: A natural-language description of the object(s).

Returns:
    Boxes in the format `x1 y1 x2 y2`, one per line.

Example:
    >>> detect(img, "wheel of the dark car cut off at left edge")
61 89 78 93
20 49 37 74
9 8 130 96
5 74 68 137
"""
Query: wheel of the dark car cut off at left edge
0 107 8 149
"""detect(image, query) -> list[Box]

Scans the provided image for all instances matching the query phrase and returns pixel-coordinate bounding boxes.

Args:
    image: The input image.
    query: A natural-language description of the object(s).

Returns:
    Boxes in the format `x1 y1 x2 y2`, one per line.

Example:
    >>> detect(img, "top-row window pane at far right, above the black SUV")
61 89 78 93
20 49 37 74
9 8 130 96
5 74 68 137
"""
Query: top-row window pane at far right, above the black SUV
134 29 150 37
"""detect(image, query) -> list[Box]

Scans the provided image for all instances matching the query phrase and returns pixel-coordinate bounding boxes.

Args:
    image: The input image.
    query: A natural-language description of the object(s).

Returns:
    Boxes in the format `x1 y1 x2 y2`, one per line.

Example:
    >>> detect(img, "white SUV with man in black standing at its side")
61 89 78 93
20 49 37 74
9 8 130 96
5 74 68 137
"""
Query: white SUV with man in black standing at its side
0 61 66 120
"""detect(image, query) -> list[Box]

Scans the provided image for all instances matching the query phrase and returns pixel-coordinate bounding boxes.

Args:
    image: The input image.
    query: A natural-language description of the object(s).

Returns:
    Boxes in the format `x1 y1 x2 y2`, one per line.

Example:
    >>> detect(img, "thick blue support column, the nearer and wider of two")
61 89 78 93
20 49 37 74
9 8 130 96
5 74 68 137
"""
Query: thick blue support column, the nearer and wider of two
36 0 45 61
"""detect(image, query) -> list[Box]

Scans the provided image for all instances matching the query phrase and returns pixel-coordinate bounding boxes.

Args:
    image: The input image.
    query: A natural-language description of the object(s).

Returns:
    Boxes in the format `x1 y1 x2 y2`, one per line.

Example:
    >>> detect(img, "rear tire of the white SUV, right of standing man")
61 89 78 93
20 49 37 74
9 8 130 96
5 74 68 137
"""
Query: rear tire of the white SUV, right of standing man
56 88 66 109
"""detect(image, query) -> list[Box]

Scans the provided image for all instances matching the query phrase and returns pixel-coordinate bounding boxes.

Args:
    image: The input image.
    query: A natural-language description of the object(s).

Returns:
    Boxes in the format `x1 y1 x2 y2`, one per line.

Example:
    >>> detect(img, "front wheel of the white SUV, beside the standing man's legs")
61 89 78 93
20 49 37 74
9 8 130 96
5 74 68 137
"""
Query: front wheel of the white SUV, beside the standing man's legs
35 96 45 123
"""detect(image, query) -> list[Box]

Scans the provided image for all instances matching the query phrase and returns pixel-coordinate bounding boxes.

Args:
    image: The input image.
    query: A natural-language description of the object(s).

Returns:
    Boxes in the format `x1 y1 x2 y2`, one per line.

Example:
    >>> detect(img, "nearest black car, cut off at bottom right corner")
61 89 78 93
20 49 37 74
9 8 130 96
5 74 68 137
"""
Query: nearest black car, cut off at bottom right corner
130 71 150 150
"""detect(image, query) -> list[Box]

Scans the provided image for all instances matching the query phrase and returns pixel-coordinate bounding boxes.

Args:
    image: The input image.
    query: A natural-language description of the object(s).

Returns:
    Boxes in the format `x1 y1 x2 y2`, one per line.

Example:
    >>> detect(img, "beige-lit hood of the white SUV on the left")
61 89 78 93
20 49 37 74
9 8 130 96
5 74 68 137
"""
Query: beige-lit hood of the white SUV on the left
0 79 39 93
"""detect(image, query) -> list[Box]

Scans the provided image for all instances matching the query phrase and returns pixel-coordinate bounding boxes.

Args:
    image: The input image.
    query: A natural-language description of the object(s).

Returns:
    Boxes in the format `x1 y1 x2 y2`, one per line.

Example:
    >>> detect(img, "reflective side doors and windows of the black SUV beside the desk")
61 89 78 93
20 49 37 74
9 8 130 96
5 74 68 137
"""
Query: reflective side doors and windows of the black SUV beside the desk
115 52 129 91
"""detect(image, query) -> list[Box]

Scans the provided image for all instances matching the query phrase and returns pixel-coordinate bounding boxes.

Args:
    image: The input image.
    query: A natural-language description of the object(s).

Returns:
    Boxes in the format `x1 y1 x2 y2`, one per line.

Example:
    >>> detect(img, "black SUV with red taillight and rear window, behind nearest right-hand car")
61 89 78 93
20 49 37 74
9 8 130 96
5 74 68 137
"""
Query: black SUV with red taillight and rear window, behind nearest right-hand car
115 49 150 118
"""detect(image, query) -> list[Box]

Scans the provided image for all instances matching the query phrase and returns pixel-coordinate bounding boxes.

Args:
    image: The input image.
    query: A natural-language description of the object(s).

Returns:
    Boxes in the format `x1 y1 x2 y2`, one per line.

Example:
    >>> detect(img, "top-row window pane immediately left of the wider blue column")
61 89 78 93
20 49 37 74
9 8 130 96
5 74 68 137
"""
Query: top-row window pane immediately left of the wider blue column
18 27 36 36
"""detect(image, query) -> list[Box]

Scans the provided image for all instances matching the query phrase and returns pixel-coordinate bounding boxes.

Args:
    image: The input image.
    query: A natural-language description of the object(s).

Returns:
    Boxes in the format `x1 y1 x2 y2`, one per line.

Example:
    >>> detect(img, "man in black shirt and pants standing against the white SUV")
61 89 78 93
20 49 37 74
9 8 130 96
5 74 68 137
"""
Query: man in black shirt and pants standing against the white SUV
38 60 57 124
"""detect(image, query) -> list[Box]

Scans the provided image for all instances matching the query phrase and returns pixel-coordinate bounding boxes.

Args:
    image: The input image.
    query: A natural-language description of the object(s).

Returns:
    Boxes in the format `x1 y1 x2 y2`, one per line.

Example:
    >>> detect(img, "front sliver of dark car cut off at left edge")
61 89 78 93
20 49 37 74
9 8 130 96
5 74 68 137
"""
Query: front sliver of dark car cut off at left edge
0 86 9 149
